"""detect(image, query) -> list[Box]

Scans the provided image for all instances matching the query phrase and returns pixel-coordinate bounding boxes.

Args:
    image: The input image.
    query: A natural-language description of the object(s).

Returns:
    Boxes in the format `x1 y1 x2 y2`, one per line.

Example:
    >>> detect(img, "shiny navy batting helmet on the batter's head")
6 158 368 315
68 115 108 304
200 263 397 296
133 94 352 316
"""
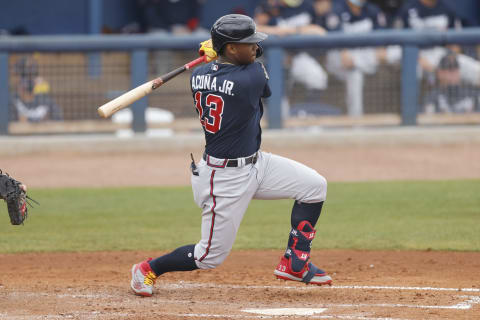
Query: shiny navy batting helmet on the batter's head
210 14 267 53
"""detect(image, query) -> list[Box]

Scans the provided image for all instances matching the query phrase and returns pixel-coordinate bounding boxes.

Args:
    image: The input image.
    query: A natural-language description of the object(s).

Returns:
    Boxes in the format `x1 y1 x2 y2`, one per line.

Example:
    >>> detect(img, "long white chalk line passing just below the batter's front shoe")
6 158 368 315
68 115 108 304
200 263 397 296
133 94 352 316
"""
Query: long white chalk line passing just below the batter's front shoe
159 281 480 292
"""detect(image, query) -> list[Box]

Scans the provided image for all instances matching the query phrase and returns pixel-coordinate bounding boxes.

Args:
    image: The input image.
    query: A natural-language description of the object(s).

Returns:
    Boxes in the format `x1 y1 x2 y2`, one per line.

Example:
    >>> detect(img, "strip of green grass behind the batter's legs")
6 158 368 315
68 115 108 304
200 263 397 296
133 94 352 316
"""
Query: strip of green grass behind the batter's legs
0 180 480 253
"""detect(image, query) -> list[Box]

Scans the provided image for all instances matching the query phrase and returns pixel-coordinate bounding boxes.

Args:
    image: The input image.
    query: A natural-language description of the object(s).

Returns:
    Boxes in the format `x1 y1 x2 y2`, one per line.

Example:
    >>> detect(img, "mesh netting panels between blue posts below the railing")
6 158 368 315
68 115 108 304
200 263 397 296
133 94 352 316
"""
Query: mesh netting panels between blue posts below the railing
9 46 480 131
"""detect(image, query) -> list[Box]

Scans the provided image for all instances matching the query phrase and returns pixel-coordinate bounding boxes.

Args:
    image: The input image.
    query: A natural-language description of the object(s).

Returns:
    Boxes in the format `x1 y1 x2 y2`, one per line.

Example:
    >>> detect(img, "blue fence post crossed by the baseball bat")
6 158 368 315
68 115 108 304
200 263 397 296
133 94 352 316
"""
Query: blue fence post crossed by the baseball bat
130 49 148 132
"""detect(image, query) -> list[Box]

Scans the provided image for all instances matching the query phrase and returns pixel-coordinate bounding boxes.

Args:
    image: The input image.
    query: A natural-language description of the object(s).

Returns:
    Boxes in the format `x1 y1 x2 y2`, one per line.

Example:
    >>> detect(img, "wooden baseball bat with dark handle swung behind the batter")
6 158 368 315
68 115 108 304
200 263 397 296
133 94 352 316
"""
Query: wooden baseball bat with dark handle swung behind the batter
97 56 206 118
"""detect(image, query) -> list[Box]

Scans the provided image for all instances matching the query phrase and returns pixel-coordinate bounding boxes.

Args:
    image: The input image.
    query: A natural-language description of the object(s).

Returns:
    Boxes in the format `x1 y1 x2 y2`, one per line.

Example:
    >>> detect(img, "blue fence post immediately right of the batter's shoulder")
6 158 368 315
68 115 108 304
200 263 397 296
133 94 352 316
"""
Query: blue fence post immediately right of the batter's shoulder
267 47 285 129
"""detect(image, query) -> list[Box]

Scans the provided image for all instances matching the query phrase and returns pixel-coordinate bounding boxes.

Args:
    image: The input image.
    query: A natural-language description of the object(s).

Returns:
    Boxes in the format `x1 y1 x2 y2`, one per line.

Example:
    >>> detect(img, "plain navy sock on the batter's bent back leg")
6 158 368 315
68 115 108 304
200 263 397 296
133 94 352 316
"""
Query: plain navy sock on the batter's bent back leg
149 244 198 277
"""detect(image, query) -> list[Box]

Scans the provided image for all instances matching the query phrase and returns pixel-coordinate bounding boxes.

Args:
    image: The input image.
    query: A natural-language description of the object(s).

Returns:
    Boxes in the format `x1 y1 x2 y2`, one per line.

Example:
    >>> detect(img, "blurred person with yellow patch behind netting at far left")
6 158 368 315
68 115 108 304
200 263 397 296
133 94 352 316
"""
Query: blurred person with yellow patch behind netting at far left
10 56 63 122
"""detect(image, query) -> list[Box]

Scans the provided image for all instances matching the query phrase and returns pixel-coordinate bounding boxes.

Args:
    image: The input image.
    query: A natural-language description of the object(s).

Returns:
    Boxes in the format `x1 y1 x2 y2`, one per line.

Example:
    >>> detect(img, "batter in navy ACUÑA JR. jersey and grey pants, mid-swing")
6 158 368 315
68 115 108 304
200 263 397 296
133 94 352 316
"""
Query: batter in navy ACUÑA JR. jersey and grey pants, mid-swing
131 14 332 296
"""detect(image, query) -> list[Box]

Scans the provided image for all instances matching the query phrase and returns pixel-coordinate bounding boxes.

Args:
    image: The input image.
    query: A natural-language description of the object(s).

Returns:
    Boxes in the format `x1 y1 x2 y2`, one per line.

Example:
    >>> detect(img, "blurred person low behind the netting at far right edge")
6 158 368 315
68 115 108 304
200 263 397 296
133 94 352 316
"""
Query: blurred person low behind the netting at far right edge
423 52 480 113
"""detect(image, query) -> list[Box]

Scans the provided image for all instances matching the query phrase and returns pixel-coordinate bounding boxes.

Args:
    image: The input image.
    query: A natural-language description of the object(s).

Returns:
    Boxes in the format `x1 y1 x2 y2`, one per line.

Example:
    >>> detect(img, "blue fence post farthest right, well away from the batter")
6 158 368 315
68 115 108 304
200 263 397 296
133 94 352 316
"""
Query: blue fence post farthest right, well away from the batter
402 45 419 126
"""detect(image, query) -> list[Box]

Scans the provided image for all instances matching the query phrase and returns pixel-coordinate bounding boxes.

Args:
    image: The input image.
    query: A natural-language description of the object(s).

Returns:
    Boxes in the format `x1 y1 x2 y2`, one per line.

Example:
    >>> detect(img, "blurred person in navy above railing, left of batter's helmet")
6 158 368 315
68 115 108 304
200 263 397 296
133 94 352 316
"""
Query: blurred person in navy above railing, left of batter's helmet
137 0 208 35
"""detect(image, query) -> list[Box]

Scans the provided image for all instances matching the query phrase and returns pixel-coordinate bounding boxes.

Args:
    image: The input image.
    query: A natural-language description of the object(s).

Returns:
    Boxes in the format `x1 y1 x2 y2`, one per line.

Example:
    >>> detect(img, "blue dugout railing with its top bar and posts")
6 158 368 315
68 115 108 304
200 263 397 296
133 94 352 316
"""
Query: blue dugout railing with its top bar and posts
0 28 480 134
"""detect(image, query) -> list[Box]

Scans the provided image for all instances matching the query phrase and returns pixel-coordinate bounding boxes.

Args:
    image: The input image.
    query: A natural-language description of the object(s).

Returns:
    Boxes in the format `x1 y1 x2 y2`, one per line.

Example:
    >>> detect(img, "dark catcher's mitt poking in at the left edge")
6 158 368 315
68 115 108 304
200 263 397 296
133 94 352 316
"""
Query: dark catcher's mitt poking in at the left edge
0 170 38 225
